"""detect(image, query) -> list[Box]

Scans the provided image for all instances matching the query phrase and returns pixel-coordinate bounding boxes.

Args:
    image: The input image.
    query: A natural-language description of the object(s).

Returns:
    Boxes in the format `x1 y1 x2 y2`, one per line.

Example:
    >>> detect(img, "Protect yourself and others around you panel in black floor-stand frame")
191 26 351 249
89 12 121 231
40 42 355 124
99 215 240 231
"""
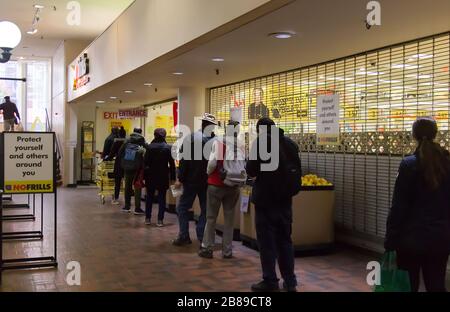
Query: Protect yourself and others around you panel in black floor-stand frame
3 132 55 194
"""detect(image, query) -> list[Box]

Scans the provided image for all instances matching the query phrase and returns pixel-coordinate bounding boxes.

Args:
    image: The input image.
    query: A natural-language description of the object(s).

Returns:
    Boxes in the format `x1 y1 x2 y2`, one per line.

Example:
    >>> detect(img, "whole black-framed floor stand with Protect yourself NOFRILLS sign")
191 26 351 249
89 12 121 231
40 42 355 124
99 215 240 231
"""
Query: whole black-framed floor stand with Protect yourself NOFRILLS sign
0 132 58 282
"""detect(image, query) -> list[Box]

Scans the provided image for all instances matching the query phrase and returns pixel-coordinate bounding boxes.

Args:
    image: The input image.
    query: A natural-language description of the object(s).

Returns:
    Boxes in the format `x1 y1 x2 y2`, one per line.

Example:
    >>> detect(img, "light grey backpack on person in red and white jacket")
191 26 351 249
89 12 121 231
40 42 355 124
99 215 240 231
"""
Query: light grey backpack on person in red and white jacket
220 138 247 187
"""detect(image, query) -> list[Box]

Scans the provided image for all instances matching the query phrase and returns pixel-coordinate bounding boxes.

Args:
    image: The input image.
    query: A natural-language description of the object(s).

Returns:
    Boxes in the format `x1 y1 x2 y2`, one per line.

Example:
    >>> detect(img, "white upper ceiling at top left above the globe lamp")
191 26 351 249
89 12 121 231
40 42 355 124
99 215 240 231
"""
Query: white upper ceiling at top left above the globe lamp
0 0 134 57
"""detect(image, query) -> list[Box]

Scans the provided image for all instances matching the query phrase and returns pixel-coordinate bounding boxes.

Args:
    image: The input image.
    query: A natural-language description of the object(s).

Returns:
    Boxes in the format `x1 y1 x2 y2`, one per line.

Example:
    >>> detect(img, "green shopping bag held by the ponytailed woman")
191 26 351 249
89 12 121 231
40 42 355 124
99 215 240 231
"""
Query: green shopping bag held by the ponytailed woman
374 251 411 292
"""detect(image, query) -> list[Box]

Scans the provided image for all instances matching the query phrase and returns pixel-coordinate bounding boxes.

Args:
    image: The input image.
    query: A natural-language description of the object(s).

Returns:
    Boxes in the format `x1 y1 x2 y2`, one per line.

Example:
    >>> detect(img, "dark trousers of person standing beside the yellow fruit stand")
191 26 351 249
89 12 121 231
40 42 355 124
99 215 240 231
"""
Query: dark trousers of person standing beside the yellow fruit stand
255 201 297 287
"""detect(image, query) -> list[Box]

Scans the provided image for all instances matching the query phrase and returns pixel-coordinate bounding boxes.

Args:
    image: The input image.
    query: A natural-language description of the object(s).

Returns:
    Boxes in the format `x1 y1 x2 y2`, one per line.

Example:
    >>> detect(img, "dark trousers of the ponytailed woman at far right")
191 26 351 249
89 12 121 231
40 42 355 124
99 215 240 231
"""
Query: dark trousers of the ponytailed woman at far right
397 250 449 292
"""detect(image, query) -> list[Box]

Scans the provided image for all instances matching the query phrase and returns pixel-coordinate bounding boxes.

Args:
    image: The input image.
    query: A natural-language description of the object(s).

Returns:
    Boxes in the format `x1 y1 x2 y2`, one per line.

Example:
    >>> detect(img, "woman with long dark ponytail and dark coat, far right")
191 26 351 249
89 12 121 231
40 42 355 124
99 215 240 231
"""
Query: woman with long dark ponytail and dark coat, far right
384 117 450 292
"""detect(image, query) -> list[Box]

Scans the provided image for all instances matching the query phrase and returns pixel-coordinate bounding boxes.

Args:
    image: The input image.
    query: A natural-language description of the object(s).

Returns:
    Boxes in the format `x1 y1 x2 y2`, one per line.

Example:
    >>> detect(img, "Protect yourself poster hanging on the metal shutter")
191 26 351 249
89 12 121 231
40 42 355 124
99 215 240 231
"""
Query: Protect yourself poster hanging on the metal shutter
317 94 340 145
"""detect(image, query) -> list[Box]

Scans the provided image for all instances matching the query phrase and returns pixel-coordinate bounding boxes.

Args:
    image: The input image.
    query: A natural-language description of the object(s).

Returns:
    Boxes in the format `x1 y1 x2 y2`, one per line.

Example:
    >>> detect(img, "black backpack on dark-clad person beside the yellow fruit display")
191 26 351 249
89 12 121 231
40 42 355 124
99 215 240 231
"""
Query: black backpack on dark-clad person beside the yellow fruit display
280 140 302 197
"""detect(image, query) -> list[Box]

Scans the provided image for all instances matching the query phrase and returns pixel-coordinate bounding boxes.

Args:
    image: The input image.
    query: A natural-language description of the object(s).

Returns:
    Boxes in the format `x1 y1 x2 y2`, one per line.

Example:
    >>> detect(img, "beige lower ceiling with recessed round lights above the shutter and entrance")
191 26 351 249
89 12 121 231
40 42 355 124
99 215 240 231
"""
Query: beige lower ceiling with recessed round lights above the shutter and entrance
71 0 450 104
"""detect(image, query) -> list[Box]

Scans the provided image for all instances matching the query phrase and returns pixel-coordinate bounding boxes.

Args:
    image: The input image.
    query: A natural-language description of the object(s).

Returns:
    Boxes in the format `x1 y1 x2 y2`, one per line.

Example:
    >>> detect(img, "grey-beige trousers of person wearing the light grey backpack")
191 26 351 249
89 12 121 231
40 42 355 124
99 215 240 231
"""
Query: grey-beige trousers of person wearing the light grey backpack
202 185 240 256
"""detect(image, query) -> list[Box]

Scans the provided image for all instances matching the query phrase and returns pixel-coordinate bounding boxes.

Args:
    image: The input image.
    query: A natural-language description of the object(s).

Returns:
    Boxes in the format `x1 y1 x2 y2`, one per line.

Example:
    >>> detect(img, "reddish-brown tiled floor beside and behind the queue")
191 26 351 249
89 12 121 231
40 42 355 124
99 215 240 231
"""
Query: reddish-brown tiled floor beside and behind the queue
0 189 374 292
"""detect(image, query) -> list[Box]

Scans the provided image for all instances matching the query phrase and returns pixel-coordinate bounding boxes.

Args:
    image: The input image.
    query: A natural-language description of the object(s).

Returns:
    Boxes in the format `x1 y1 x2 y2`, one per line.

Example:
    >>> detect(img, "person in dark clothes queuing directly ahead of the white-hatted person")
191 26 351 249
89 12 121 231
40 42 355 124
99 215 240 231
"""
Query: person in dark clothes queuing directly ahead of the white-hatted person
144 129 176 227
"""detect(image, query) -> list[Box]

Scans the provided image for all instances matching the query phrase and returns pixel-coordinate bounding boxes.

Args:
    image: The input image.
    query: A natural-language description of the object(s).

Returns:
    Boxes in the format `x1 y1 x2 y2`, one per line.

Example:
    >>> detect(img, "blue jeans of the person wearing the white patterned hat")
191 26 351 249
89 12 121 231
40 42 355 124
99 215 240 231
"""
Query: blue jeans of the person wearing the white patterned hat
177 184 208 241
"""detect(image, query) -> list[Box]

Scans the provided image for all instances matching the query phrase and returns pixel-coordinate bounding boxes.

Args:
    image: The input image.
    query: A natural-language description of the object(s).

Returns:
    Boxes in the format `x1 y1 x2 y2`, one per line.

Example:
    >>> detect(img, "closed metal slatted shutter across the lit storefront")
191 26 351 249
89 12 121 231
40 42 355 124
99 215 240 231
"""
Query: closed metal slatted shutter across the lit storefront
210 33 450 245
